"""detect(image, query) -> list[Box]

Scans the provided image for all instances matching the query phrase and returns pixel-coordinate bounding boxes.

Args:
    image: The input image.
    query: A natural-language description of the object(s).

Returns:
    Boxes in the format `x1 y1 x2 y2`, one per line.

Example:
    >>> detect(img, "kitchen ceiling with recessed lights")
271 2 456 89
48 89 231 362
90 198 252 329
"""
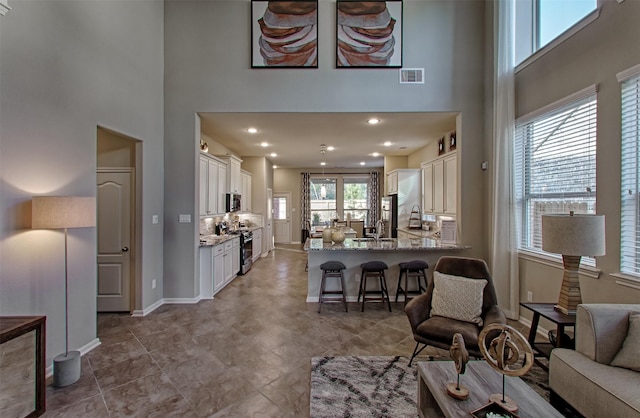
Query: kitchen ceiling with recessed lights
200 112 457 168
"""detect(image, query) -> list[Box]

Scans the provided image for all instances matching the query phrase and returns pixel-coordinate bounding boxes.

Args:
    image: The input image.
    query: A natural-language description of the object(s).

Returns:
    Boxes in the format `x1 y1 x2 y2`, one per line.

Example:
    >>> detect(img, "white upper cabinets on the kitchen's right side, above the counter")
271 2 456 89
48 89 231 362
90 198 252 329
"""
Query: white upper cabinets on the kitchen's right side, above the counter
421 152 458 216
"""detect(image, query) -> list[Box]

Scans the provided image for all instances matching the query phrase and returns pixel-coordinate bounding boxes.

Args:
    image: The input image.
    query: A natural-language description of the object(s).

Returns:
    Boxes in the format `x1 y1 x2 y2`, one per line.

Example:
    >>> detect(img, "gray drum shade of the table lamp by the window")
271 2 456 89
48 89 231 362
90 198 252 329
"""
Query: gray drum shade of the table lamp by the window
542 214 605 256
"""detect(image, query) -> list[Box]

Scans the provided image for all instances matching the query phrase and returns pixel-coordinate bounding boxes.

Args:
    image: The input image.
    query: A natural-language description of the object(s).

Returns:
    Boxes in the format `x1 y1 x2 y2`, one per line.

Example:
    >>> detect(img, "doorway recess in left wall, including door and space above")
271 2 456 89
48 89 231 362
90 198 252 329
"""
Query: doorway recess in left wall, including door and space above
96 127 142 313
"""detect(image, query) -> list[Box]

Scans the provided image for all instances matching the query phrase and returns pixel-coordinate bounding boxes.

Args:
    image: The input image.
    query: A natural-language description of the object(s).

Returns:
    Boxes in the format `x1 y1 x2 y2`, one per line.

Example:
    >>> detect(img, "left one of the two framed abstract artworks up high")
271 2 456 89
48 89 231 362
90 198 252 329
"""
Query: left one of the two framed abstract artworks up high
251 0 318 68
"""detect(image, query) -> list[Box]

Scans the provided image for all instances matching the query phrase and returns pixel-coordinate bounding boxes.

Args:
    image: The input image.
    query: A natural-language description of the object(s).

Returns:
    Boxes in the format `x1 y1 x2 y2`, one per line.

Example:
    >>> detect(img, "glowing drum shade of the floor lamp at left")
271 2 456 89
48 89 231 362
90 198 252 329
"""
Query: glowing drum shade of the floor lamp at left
31 196 96 229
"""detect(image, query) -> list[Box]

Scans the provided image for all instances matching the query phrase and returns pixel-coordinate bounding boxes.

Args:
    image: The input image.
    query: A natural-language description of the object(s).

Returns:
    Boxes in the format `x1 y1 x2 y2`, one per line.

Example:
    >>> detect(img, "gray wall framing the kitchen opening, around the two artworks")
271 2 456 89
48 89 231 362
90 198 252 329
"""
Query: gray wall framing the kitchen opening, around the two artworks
165 0 486 298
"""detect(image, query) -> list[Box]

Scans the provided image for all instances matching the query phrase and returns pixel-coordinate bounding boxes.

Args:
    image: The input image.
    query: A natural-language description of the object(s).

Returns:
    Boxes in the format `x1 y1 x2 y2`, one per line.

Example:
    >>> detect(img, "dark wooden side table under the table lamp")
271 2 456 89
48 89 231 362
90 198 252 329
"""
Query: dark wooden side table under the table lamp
520 303 576 371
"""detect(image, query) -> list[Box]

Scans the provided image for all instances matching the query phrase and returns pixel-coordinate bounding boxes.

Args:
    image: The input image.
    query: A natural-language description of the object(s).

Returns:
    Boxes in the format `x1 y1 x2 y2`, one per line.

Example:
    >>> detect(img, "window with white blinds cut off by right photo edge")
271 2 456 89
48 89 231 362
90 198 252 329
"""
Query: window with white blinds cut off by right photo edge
618 65 640 275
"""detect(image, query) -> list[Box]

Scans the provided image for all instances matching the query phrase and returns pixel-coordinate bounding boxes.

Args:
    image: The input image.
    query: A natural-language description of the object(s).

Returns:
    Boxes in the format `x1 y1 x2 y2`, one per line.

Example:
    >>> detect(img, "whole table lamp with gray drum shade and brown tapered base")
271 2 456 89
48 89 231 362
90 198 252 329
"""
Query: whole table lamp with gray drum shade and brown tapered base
542 211 605 314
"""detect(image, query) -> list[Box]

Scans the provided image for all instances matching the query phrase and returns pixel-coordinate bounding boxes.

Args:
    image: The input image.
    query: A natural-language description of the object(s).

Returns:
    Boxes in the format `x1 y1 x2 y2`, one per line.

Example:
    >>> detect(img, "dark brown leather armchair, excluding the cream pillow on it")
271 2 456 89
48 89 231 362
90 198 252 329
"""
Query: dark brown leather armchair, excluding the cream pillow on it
405 257 507 366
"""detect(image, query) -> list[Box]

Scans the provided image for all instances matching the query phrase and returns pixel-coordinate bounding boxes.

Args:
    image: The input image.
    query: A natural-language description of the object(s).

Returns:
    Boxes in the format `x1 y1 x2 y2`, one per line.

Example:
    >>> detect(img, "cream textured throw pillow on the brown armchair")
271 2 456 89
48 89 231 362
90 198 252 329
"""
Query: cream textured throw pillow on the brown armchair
430 271 487 326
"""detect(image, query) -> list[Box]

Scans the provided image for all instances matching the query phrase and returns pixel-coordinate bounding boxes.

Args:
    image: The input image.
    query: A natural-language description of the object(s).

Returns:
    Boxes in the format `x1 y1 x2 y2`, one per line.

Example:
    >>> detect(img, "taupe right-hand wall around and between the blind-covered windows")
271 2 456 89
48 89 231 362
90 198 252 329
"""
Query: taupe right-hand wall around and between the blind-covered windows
516 0 640 316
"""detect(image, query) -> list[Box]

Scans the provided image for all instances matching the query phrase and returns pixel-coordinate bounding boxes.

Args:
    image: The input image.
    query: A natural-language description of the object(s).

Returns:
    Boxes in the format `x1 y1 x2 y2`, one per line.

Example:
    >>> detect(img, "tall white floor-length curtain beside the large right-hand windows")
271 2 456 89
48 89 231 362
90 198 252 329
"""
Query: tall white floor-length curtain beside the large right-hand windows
490 0 520 319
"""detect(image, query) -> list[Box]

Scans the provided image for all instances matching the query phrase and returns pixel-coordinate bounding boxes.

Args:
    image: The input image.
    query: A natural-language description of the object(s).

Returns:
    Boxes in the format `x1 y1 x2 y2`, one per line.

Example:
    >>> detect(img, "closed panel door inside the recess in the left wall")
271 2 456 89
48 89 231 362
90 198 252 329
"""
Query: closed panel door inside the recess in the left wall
97 170 133 312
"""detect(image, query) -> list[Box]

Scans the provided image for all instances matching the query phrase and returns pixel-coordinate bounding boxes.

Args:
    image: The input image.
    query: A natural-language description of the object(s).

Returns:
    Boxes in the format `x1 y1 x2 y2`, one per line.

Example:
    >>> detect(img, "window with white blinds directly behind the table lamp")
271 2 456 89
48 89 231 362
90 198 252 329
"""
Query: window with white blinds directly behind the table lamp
514 87 596 264
